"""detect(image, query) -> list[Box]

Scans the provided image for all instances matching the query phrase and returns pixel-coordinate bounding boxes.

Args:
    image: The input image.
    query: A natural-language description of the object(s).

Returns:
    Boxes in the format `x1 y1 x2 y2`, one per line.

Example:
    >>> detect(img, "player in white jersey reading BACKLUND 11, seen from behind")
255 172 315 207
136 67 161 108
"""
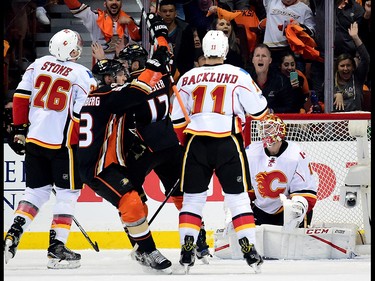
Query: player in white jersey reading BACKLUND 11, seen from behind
172 30 268 271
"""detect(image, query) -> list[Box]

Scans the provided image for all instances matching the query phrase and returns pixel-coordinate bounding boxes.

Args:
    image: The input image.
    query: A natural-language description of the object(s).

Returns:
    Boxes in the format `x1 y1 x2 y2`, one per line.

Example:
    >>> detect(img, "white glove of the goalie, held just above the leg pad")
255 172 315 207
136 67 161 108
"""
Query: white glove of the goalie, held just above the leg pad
280 194 309 231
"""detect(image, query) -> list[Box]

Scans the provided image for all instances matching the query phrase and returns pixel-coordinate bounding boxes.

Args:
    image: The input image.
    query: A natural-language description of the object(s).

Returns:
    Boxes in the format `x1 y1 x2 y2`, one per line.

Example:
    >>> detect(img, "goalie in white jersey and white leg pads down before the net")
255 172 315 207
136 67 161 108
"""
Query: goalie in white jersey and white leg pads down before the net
214 114 364 259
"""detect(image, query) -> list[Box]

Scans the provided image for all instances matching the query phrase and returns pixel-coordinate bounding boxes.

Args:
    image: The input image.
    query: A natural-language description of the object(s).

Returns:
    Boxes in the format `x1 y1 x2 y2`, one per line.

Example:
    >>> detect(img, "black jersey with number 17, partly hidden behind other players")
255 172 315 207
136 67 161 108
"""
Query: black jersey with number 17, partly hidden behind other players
132 72 179 151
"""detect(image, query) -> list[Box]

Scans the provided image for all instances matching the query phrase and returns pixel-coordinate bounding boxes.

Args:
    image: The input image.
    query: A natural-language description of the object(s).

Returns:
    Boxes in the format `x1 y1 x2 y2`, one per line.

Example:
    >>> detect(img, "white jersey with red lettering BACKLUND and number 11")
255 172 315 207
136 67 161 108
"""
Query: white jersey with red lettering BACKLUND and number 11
172 64 267 137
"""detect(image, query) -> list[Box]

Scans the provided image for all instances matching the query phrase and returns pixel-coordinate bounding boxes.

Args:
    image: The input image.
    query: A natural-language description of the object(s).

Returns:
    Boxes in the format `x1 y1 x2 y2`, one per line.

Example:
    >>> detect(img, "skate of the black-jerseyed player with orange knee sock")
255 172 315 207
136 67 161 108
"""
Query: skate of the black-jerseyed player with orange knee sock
139 250 172 274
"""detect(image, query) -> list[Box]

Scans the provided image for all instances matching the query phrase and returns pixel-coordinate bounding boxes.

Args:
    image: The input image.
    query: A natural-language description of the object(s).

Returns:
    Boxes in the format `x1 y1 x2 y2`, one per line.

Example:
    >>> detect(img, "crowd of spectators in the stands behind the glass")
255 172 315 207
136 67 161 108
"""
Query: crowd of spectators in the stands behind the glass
3 0 372 137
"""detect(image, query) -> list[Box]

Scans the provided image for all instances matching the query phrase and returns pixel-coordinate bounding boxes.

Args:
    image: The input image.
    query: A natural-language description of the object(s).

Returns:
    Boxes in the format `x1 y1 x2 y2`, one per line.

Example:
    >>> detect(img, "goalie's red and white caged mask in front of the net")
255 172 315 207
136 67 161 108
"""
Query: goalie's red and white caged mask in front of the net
258 114 286 147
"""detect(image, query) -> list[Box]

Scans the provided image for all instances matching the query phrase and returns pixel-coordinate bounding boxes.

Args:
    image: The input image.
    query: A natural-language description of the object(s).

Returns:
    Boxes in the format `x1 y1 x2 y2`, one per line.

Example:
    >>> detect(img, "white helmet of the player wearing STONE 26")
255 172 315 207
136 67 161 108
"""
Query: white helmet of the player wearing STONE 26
49 29 83 61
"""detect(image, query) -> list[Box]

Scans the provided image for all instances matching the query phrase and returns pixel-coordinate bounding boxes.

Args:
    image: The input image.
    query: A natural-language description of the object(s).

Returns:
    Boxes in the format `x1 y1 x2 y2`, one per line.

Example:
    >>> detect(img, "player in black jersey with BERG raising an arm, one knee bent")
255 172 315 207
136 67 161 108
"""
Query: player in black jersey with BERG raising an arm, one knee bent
78 32 172 273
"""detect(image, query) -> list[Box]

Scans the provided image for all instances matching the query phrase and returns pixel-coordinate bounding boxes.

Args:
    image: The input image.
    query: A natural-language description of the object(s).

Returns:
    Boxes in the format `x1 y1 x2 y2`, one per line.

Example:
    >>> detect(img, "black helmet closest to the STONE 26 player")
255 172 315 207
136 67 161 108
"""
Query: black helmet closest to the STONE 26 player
92 59 125 85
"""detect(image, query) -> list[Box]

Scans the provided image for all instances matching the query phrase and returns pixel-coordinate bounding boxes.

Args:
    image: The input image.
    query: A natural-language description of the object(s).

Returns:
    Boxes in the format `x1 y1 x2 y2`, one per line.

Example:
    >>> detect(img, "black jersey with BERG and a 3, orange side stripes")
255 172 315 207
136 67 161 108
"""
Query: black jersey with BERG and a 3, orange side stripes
78 81 147 183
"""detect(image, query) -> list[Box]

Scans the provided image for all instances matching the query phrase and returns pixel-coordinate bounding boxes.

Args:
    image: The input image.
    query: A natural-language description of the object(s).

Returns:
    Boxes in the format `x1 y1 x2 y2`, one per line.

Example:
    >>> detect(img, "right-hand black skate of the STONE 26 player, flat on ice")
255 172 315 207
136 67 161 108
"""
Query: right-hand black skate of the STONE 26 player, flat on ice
47 237 81 269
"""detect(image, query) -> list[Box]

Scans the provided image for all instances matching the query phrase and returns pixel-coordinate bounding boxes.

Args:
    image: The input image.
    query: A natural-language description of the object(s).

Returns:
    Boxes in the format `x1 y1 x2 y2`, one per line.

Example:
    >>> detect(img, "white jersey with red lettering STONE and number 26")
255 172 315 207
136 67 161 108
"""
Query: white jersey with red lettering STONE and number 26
13 56 97 149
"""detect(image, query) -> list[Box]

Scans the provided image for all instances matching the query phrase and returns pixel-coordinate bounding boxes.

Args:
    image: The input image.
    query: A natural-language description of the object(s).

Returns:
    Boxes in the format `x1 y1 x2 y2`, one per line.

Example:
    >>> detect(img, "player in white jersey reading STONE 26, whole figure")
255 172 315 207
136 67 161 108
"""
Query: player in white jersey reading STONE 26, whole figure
4 29 97 268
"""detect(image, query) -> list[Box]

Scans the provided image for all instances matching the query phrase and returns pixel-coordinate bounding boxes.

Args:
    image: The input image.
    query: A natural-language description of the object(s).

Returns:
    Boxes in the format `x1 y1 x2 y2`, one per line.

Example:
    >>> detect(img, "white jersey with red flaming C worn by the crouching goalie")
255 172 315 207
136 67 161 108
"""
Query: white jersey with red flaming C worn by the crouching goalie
246 141 317 214
